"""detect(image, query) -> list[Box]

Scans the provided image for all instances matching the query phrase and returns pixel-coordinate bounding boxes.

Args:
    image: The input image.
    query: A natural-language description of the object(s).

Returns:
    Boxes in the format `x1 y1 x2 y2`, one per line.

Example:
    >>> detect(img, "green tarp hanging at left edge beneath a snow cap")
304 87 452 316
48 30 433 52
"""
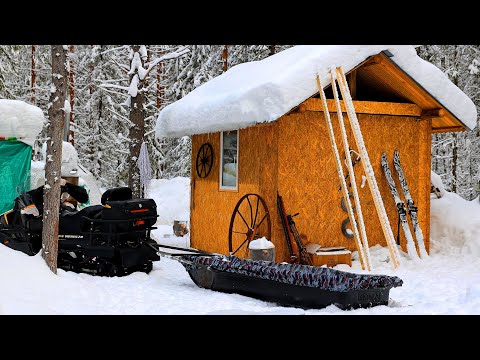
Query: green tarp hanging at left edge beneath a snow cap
0 140 32 214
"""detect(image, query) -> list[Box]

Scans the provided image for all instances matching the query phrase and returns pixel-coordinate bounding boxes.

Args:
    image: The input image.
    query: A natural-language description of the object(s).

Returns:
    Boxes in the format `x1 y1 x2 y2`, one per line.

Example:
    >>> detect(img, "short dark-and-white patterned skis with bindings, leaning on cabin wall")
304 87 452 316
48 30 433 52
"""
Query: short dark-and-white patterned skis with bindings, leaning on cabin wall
381 150 428 259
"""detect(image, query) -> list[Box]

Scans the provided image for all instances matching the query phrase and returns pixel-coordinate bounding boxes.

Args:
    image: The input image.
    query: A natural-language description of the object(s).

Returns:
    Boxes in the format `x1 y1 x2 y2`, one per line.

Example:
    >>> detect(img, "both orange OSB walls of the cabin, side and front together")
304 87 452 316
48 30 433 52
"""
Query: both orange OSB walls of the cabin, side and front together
191 111 431 261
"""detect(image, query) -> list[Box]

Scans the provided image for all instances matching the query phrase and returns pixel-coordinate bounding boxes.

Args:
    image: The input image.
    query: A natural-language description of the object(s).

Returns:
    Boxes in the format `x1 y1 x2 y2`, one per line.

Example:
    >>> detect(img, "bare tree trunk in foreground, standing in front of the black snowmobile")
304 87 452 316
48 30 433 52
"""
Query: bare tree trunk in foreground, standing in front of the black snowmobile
42 45 68 274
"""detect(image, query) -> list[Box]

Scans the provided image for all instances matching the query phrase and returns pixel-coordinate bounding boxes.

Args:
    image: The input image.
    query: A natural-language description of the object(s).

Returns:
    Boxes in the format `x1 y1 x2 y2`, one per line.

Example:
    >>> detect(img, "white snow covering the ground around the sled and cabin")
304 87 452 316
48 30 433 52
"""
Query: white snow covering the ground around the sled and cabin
0 178 480 315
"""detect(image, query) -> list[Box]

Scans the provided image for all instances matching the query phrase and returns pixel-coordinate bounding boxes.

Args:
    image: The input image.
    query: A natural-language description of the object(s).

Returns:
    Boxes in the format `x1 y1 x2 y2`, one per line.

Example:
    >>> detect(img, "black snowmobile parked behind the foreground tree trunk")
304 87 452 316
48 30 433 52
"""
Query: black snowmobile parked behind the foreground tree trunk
0 183 160 276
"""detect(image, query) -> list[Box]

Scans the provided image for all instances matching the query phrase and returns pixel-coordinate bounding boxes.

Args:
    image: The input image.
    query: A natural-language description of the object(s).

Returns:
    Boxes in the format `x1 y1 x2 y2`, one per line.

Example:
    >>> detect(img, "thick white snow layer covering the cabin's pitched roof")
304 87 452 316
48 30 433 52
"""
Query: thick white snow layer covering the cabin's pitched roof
155 45 477 137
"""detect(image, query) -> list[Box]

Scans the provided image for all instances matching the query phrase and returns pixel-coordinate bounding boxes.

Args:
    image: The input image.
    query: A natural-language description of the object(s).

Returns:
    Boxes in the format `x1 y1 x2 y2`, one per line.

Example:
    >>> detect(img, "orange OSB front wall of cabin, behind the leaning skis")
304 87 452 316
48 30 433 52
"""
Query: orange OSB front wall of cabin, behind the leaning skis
276 112 430 260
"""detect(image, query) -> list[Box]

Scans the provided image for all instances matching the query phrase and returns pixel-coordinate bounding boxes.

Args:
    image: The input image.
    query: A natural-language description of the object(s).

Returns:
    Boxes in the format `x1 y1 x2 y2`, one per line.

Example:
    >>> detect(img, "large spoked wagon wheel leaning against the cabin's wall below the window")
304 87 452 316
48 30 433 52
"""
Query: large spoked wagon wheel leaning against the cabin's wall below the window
228 194 272 257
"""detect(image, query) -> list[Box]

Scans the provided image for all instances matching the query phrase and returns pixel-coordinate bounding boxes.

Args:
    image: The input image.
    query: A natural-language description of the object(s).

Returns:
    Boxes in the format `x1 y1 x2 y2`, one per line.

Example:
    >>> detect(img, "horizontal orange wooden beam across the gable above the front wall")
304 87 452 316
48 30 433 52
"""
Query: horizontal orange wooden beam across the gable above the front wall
299 98 422 117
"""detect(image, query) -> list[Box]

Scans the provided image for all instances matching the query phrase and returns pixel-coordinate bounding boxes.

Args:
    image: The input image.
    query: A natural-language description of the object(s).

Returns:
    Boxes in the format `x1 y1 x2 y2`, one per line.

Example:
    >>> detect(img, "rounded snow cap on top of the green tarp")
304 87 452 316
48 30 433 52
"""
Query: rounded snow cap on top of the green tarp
0 99 45 146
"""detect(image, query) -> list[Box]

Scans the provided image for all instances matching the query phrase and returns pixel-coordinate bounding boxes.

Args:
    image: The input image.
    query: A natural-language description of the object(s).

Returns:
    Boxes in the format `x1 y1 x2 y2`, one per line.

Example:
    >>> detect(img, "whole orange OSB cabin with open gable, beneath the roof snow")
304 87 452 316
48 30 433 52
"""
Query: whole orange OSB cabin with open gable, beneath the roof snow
157 45 472 262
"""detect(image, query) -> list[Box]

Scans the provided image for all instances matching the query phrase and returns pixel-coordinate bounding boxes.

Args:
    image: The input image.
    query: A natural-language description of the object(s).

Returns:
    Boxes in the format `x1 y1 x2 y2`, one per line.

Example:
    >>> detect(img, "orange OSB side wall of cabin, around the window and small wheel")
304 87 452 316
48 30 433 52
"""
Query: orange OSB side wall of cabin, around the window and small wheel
190 124 277 254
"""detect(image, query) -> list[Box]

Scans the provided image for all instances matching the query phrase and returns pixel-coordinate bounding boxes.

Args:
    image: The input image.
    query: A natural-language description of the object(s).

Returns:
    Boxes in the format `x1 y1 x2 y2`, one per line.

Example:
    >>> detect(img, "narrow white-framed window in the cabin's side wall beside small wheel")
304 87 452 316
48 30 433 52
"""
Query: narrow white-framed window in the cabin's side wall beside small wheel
220 130 238 190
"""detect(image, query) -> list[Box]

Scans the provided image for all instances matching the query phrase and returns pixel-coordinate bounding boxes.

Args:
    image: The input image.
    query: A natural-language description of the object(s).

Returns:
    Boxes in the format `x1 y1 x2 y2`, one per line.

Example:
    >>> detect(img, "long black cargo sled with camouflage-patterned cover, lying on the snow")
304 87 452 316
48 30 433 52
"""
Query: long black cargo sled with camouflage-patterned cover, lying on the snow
157 245 403 310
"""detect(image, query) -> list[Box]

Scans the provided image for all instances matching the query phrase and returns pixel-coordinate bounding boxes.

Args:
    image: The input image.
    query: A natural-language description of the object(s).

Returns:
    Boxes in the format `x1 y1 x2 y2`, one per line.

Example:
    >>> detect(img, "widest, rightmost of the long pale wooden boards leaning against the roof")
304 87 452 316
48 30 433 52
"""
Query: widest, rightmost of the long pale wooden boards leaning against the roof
336 67 400 268
